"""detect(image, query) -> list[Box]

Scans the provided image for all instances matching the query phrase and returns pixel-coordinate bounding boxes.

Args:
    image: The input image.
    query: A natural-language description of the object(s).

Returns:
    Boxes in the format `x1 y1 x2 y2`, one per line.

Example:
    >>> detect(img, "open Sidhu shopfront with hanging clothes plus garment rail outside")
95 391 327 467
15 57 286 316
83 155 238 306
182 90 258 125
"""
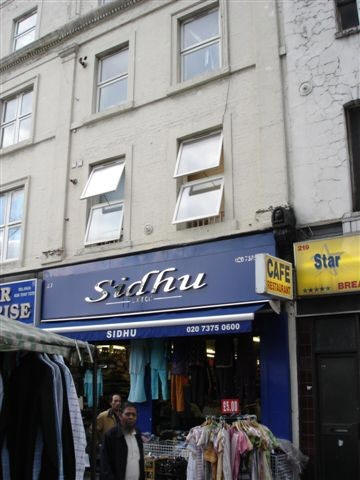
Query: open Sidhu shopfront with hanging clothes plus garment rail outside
69 332 306 480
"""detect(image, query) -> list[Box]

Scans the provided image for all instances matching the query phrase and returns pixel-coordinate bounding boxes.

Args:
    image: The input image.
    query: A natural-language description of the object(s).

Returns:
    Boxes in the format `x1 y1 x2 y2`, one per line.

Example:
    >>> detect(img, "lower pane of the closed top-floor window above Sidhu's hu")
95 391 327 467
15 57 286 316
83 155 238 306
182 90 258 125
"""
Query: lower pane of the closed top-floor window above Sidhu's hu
182 42 220 80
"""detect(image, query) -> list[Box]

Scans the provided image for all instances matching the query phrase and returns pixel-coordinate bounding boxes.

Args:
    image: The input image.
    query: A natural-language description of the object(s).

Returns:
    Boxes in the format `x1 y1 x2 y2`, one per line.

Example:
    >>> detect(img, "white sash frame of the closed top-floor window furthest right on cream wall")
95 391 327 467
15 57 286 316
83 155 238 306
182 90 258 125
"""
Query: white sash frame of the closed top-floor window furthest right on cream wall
179 5 222 82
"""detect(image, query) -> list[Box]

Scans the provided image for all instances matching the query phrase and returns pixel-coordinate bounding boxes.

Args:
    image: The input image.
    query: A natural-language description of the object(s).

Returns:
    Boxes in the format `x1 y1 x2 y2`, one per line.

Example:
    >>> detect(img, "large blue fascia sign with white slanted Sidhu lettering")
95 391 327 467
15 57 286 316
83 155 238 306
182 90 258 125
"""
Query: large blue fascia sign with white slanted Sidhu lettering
42 233 275 321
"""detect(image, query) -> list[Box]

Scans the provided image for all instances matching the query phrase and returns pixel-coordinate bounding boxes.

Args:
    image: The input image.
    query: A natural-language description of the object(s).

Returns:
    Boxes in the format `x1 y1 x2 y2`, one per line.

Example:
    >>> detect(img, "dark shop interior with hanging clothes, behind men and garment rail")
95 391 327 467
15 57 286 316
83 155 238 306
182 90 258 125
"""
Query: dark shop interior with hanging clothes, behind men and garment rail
74 334 260 439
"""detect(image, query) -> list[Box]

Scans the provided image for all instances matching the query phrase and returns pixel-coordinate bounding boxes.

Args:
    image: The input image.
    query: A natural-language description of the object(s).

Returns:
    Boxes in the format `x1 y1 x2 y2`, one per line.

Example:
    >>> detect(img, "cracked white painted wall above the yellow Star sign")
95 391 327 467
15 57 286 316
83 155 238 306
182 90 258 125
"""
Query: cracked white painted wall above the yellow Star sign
282 0 360 225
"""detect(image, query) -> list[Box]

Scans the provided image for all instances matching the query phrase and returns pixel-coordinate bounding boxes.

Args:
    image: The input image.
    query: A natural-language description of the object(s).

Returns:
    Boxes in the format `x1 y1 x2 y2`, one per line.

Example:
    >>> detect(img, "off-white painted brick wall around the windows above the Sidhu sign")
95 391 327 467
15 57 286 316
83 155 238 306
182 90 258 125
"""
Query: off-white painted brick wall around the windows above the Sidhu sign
0 0 286 274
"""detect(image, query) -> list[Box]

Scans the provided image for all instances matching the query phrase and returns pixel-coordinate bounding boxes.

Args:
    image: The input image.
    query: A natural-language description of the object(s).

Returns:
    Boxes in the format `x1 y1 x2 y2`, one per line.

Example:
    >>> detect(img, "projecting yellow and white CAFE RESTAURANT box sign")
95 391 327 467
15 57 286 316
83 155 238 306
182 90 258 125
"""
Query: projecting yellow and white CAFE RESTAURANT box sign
255 253 293 300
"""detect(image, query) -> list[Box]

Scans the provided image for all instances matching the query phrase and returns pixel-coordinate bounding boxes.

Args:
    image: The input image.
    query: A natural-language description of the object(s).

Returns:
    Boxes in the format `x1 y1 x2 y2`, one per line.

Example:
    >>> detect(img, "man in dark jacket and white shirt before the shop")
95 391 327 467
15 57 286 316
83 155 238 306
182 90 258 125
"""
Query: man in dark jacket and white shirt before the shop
100 403 145 480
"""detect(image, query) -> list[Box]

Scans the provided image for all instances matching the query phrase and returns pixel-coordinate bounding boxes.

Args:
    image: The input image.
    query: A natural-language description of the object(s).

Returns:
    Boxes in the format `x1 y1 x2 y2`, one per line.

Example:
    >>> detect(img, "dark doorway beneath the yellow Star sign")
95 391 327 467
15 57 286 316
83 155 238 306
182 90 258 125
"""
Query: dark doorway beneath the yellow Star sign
315 321 360 480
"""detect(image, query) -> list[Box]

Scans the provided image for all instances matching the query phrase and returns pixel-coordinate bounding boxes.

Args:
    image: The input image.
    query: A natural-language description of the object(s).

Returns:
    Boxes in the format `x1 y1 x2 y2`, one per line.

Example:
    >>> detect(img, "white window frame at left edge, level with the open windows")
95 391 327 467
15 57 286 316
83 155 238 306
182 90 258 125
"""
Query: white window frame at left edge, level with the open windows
0 185 26 264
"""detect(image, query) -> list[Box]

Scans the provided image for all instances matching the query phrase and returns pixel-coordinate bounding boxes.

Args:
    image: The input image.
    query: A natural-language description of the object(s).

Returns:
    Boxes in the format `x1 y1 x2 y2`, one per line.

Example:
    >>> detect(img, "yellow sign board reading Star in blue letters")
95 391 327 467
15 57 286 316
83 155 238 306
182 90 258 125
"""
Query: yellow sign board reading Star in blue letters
294 235 360 296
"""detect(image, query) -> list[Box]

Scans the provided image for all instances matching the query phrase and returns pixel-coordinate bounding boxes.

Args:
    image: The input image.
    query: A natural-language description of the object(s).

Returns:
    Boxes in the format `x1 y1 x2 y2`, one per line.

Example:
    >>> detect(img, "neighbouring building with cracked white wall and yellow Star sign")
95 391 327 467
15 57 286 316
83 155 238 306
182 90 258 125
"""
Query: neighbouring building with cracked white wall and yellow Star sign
283 0 360 480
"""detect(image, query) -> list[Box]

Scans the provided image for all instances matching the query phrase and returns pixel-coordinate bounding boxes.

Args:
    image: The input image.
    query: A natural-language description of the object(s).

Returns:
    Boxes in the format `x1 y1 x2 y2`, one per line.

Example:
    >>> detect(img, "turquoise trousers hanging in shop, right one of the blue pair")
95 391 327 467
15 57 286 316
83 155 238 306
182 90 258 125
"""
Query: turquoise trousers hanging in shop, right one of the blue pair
150 338 169 400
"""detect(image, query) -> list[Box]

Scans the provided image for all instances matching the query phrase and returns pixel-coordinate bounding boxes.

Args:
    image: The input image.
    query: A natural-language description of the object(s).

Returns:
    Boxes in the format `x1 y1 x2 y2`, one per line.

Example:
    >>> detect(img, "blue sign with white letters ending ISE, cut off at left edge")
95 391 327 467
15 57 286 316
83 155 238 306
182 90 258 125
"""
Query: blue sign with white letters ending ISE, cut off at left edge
0 279 41 325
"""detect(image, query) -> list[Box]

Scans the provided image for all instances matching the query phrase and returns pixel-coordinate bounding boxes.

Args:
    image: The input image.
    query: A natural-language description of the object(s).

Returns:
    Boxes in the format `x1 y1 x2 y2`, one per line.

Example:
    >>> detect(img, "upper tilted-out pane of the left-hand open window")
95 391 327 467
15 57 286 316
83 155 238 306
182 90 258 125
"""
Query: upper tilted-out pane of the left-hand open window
81 163 125 199
